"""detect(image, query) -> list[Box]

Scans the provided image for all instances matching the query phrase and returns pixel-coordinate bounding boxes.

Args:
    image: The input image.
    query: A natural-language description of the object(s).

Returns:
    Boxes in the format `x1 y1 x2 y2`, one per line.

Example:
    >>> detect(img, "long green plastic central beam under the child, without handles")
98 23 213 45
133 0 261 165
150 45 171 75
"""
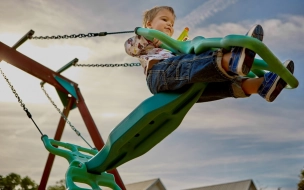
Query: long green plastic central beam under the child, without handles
86 83 206 173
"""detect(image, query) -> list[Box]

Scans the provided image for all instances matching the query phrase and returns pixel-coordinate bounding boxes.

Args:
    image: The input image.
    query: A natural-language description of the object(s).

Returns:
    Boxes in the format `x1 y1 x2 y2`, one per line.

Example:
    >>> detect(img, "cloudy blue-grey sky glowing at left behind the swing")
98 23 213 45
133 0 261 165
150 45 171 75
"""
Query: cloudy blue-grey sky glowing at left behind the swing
0 0 304 190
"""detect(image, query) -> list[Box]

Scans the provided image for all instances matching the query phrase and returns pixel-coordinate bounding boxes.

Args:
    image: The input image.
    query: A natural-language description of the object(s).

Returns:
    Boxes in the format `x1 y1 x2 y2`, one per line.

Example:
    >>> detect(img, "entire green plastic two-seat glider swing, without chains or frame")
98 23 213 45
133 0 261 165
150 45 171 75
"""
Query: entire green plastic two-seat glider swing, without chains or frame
42 28 298 190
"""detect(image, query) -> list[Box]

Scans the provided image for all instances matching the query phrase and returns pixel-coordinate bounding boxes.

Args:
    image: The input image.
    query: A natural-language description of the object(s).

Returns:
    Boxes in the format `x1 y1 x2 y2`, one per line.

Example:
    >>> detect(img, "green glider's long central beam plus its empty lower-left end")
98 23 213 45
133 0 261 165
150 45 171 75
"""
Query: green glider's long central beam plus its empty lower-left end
42 83 206 190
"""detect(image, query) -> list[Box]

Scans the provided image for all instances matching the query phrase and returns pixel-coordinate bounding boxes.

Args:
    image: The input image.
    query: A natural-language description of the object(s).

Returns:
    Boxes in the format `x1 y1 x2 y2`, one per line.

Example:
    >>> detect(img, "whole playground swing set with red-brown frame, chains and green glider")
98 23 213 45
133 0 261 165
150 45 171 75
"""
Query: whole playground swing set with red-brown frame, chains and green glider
0 27 299 190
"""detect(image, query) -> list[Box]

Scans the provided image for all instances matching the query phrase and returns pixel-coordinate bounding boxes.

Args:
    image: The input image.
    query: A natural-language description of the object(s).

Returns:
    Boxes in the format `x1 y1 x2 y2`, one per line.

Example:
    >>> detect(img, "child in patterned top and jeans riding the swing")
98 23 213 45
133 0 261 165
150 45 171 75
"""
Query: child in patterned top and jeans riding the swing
125 6 294 102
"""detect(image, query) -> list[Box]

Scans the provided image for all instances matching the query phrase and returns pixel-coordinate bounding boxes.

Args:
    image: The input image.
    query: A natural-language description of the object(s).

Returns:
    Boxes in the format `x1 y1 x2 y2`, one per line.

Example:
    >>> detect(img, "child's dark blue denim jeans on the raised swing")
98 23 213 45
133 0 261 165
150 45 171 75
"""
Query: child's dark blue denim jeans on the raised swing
147 50 249 102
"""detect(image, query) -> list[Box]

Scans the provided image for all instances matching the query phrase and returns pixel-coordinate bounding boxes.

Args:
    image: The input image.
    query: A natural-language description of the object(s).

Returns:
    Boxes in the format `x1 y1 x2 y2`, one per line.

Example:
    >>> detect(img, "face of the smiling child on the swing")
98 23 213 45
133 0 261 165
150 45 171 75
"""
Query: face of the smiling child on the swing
146 9 174 37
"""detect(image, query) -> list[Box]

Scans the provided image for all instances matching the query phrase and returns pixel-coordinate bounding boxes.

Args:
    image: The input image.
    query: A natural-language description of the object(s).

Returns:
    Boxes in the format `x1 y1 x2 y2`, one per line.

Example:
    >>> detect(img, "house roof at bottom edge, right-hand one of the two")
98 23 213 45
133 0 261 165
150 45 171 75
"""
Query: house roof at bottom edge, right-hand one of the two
186 179 257 190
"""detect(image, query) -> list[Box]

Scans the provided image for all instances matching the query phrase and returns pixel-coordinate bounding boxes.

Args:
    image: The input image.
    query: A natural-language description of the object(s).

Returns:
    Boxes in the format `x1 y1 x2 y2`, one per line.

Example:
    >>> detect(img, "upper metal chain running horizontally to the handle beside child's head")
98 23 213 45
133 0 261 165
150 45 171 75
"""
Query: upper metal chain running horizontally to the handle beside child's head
29 31 134 40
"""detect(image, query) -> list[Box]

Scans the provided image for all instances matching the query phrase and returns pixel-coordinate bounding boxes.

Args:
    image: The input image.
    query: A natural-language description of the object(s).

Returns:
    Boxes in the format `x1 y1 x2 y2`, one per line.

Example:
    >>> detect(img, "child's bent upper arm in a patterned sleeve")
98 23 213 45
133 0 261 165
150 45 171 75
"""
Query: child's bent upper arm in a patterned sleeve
125 35 148 57
